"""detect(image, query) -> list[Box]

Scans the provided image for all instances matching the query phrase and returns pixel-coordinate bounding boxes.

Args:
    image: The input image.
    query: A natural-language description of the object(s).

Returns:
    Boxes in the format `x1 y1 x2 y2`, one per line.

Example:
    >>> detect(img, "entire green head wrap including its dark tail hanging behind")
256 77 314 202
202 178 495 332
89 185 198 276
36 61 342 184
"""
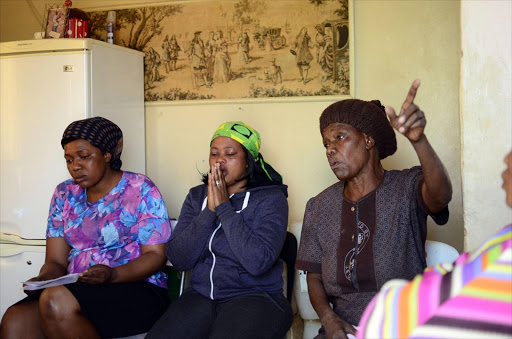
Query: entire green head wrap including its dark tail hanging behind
210 121 282 181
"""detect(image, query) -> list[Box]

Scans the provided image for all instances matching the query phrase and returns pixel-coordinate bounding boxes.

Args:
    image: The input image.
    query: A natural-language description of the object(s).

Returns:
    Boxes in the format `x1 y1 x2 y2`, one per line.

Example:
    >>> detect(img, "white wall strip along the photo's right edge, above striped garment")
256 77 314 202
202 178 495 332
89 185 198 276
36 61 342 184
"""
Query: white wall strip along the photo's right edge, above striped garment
460 1 512 249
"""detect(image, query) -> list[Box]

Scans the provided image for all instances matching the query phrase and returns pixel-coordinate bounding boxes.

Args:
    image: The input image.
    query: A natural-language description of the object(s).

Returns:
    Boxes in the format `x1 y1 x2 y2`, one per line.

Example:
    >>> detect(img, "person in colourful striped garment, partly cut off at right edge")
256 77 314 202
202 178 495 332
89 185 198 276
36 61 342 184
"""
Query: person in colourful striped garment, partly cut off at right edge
357 151 512 338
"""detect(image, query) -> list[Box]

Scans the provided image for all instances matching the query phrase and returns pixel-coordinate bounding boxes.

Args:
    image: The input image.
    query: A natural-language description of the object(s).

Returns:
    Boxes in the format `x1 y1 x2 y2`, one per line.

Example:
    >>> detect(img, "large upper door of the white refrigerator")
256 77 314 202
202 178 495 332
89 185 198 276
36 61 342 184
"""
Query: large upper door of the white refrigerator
0 51 90 242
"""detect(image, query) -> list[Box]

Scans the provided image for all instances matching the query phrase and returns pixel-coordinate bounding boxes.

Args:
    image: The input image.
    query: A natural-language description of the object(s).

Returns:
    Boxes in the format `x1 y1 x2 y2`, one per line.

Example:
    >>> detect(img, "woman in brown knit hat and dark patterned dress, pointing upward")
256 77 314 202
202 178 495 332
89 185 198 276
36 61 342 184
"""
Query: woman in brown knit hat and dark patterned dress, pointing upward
296 80 452 338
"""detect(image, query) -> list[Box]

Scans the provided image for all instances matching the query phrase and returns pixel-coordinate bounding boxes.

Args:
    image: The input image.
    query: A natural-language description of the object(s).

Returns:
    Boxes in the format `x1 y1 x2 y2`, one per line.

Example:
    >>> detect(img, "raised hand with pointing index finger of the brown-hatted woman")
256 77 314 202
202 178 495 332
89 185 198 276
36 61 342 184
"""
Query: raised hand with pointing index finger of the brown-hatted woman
386 79 427 142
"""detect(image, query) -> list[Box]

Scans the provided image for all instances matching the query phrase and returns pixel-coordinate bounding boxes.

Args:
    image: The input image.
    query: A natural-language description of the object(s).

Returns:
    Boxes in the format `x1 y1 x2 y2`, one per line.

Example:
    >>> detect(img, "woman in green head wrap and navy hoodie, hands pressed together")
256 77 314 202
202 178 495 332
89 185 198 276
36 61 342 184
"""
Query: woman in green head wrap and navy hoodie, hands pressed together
147 121 292 338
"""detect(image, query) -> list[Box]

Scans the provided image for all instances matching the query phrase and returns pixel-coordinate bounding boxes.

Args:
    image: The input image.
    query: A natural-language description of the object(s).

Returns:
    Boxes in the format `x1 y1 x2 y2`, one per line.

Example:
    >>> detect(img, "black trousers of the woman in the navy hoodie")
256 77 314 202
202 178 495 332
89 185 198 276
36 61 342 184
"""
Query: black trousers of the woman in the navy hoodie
146 288 293 339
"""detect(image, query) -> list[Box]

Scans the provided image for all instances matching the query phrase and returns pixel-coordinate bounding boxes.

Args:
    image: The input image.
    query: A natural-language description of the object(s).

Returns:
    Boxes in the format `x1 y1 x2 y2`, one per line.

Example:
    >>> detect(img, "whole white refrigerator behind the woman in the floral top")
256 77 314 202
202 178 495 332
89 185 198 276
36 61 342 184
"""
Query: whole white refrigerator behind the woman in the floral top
0 39 145 317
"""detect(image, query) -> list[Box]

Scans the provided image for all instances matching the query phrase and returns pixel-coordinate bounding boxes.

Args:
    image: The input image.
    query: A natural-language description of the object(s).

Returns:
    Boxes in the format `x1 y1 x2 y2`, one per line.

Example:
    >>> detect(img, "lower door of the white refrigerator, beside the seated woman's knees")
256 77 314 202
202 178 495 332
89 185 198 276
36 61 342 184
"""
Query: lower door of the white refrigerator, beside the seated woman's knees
0 243 45 318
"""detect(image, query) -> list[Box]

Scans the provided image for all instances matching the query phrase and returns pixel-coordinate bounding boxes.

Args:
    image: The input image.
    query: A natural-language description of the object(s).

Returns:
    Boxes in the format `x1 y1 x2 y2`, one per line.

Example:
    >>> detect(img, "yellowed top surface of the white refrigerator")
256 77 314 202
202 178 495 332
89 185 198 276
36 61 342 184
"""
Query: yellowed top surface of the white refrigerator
0 39 144 56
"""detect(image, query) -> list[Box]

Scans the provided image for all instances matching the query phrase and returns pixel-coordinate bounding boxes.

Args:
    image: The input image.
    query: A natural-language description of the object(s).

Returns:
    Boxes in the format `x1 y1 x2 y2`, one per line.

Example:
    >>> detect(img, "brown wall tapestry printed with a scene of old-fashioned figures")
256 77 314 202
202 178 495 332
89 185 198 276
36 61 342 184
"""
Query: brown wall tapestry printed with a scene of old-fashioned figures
89 0 351 101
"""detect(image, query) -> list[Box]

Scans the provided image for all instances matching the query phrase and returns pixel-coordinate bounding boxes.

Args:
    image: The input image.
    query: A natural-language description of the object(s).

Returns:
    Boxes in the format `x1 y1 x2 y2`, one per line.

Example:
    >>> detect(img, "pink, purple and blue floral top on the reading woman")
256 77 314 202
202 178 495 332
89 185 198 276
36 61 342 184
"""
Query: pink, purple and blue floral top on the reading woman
46 172 171 288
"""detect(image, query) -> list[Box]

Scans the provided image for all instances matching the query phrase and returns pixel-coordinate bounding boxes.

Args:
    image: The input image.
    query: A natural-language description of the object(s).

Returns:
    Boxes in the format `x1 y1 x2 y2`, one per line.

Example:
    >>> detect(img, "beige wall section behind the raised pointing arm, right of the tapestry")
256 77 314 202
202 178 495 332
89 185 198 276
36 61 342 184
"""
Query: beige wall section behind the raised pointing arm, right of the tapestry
355 0 463 251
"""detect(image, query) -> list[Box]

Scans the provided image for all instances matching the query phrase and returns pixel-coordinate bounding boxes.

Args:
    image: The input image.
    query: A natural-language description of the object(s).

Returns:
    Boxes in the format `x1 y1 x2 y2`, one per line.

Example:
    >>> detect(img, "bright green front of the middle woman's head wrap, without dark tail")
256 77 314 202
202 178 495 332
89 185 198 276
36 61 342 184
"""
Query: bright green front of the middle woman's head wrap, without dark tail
210 121 261 161
